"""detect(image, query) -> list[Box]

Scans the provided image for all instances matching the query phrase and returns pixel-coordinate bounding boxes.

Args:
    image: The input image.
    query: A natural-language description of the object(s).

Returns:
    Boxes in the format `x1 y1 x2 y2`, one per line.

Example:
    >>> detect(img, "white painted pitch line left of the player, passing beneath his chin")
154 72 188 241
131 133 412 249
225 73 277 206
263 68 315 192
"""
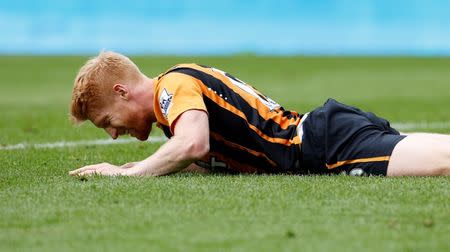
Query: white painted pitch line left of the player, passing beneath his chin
0 136 167 150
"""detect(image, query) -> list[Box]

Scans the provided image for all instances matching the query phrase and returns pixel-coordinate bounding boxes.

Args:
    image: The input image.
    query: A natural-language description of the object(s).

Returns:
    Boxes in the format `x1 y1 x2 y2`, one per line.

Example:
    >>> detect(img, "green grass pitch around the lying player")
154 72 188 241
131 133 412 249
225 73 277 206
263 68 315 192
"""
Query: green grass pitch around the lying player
0 55 450 251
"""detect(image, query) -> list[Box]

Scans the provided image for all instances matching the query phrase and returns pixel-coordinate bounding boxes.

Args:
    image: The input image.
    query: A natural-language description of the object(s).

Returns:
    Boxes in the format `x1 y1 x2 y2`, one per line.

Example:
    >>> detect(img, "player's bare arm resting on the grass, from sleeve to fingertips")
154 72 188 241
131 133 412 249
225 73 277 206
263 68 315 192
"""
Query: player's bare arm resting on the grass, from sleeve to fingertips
70 110 209 176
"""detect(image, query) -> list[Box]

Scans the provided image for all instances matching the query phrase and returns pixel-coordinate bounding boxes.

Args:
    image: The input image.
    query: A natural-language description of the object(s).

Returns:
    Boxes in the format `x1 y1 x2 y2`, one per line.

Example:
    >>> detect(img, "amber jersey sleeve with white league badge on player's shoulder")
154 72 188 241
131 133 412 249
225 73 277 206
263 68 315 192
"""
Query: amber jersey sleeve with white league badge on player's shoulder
157 72 208 133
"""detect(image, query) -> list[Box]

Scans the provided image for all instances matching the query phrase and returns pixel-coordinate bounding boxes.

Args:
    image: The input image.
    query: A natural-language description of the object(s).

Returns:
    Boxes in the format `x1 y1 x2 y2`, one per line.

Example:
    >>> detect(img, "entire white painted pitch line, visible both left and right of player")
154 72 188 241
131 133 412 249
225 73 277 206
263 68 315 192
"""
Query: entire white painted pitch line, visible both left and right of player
0 122 450 151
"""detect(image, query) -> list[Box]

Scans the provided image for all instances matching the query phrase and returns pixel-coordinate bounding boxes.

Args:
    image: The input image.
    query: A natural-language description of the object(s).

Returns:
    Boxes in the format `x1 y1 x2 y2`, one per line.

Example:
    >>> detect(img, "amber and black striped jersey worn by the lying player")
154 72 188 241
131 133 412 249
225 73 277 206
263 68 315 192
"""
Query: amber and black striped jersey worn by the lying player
154 64 301 173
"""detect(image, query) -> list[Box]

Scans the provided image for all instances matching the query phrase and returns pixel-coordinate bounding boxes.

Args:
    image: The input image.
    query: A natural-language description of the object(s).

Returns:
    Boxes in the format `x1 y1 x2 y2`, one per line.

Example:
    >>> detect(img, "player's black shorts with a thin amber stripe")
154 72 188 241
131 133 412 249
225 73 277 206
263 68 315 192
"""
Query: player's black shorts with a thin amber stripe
301 99 405 176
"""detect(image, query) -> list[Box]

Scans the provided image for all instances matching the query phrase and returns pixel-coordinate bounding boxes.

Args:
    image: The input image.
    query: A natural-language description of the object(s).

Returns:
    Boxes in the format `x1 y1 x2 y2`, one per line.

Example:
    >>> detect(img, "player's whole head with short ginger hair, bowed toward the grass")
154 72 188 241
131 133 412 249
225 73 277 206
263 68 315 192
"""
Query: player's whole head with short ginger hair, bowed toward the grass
70 52 151 140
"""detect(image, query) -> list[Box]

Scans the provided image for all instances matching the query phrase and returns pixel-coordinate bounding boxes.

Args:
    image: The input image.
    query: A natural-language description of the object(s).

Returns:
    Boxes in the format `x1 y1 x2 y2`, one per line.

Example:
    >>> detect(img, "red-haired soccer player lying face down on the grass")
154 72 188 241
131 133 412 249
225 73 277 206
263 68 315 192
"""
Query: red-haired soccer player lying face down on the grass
70 52 450 176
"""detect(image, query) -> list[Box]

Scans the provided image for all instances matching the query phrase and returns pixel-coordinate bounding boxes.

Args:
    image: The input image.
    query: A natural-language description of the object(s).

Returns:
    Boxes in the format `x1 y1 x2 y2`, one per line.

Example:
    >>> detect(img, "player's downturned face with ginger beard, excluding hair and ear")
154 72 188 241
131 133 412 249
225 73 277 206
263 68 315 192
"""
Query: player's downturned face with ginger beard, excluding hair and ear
92 100 152 141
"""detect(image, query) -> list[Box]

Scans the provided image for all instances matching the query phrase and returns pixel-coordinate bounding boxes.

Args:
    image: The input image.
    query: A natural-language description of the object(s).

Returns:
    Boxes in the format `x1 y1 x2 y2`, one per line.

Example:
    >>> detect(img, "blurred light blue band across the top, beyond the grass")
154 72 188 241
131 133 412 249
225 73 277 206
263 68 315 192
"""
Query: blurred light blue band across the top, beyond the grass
0 0 450 56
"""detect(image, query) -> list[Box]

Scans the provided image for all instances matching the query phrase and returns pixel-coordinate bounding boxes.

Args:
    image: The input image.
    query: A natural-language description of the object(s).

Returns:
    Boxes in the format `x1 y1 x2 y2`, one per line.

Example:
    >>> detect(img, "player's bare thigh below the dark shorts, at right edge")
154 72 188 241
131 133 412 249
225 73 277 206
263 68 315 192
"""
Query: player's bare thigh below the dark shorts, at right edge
387 133 450 176
